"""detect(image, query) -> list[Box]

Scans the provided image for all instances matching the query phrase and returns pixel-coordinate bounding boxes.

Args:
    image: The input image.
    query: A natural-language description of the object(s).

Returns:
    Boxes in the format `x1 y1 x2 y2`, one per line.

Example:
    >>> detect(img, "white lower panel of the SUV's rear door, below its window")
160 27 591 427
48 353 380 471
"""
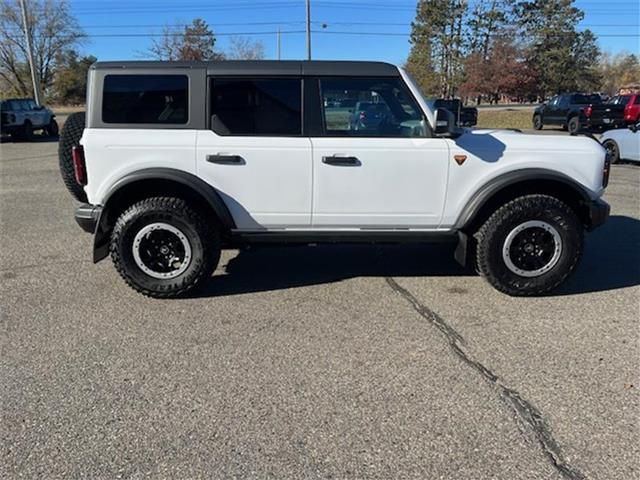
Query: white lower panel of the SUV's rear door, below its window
197 131 312 230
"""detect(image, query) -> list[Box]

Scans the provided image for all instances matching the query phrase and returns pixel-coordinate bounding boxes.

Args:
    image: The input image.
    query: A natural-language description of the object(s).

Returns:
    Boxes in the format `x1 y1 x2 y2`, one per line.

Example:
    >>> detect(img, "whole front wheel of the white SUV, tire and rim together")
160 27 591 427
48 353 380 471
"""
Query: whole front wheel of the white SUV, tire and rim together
475 195 584 296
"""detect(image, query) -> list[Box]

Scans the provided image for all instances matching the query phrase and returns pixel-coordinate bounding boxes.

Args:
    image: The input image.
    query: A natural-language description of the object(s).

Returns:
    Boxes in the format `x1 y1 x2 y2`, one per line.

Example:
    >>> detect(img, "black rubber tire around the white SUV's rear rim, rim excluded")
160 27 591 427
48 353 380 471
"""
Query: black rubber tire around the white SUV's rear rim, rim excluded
110 197 220 298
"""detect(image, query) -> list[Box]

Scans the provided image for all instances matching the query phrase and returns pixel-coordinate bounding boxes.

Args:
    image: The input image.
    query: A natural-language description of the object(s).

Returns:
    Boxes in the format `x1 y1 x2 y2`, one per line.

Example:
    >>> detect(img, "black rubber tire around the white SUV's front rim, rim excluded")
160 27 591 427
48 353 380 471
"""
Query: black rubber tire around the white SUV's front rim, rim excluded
474 195 584 296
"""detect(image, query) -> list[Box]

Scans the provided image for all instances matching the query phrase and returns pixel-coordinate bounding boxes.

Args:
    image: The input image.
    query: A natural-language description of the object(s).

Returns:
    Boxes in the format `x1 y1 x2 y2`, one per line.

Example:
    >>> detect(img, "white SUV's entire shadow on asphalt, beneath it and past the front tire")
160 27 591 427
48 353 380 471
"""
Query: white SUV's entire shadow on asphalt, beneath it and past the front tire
189 216 640 298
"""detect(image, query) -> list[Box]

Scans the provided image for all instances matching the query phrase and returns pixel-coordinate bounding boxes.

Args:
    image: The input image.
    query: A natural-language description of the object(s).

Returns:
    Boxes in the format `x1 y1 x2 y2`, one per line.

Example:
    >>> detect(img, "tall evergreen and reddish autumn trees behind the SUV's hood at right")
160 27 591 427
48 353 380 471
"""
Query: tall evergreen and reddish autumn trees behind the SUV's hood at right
406 0 640 103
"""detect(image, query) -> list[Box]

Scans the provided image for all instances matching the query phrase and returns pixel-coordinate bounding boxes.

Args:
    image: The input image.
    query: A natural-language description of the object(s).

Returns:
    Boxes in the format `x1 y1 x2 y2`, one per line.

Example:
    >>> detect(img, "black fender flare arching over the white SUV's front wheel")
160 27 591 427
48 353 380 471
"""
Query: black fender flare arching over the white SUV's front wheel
454 168 591 230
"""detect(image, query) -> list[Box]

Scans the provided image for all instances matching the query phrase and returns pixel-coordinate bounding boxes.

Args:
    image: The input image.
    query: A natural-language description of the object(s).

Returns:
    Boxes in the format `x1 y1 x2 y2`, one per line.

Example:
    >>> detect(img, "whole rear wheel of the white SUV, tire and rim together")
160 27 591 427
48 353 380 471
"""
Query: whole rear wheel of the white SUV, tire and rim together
110 197 220 298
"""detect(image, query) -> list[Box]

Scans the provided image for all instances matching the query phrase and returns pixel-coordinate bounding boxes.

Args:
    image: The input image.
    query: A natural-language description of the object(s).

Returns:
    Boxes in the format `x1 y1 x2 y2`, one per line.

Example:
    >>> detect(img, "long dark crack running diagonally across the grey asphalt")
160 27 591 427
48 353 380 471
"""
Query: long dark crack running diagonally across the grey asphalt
385 277 586 480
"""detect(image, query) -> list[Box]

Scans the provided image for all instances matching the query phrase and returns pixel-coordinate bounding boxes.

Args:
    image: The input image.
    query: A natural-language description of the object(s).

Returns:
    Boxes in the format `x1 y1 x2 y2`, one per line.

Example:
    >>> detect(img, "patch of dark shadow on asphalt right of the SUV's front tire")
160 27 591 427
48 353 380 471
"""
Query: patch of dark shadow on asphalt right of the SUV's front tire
552 215 640 295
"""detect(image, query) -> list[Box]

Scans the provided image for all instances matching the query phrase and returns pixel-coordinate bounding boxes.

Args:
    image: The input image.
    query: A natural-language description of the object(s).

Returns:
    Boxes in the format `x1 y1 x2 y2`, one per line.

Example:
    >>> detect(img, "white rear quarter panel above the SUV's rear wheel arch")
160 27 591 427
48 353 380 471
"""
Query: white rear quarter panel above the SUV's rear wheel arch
80 128 196 205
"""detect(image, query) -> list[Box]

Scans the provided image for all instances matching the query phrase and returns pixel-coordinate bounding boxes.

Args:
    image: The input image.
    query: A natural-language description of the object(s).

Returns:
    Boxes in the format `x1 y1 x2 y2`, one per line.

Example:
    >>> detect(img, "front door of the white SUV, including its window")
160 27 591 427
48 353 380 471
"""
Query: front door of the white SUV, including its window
311 77 449 229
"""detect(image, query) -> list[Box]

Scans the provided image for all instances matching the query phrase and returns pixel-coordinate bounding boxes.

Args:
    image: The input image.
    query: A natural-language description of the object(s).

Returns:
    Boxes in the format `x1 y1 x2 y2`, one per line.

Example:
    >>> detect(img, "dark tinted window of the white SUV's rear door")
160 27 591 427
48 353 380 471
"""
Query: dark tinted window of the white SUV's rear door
210 78 302 136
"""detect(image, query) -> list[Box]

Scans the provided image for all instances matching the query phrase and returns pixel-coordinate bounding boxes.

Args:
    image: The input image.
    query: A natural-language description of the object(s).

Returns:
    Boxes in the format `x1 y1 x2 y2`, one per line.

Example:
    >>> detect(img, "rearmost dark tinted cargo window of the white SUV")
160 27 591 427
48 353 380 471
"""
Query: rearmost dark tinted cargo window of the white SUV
102 75 189 125
